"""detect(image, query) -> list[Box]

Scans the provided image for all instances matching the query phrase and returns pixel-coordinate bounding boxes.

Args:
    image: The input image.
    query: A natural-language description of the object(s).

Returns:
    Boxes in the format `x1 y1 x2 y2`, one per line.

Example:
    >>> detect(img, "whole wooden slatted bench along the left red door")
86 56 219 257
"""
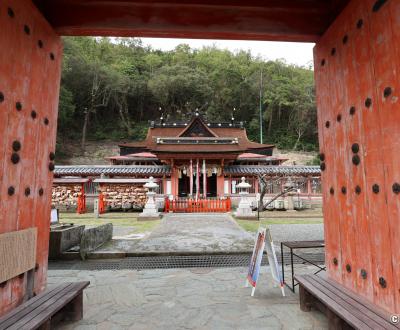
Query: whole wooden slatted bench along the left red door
0 282 90 330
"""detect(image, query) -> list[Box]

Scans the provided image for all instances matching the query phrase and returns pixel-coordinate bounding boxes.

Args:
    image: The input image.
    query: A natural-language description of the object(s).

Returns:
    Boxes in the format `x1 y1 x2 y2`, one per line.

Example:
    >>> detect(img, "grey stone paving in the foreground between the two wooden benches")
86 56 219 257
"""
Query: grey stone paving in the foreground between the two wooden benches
48 267 328 330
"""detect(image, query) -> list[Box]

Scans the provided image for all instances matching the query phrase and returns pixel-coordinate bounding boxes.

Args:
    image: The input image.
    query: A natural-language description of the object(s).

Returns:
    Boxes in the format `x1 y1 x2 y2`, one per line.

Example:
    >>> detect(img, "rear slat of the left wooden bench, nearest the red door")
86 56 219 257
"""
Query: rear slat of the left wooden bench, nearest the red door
0 283 70 329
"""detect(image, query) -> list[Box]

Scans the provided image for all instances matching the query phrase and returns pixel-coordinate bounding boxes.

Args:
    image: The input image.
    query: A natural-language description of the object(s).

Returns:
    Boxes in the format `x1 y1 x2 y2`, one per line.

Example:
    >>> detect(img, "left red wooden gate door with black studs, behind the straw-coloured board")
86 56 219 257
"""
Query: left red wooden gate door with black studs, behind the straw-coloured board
0 0 62 315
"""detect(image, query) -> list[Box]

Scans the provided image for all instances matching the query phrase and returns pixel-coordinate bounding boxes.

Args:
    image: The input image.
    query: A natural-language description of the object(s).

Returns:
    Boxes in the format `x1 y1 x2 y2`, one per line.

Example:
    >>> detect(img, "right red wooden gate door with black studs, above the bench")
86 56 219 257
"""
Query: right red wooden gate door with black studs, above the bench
314 0 400 313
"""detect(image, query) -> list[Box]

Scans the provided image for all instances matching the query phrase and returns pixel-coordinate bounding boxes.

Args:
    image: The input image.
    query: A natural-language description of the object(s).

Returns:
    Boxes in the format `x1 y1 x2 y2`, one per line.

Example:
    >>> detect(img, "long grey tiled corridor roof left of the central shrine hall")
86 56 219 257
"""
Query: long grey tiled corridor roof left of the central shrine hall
54 165 171 176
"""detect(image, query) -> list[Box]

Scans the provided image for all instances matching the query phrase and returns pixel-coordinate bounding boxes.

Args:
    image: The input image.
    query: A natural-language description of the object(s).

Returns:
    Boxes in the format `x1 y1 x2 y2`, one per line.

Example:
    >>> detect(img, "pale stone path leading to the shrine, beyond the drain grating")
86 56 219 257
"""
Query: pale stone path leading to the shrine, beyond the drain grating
96 214 254 253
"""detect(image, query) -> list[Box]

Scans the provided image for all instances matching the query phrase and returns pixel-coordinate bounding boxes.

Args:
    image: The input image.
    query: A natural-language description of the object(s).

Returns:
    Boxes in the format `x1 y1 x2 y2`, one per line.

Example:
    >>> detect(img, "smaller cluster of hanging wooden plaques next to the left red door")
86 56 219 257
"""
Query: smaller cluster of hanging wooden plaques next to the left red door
51 184 82 211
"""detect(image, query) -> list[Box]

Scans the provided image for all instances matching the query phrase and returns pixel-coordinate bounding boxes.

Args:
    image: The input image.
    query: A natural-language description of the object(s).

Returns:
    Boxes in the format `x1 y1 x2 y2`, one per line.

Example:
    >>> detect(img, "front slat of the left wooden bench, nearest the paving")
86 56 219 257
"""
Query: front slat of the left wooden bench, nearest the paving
8 282 89 330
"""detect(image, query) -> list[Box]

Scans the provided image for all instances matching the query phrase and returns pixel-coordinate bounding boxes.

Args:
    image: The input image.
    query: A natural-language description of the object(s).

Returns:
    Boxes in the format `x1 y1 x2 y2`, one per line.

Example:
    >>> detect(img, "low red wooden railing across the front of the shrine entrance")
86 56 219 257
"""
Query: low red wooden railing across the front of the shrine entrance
165 198 231 213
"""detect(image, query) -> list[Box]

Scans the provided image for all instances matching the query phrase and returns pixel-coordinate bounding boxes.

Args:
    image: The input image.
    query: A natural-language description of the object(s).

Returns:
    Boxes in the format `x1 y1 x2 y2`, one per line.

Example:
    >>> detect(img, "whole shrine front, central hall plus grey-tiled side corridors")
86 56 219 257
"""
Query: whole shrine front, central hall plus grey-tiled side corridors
53 111 320 208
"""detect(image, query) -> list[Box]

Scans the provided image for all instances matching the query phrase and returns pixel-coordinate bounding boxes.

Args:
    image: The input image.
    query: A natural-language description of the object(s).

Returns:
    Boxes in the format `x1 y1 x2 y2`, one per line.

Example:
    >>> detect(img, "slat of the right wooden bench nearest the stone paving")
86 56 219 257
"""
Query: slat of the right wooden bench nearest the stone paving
297 275 374 330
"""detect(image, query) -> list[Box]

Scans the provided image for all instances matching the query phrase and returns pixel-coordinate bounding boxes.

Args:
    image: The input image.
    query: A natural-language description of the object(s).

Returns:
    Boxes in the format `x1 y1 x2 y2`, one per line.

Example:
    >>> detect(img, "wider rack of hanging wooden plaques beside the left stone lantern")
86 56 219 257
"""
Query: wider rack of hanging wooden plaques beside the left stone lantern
100 184 147 209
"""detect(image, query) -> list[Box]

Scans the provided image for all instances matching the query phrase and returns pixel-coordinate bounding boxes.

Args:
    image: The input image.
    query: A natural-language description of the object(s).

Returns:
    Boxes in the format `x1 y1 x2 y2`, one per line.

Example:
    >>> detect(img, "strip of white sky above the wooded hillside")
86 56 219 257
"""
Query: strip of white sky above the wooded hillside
141 38 314 67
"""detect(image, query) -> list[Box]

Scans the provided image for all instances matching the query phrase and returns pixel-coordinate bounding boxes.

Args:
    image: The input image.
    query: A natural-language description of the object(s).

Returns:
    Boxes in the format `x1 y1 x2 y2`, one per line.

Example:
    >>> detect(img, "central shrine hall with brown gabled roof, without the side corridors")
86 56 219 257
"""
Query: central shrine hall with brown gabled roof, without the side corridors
109 111 284 198
